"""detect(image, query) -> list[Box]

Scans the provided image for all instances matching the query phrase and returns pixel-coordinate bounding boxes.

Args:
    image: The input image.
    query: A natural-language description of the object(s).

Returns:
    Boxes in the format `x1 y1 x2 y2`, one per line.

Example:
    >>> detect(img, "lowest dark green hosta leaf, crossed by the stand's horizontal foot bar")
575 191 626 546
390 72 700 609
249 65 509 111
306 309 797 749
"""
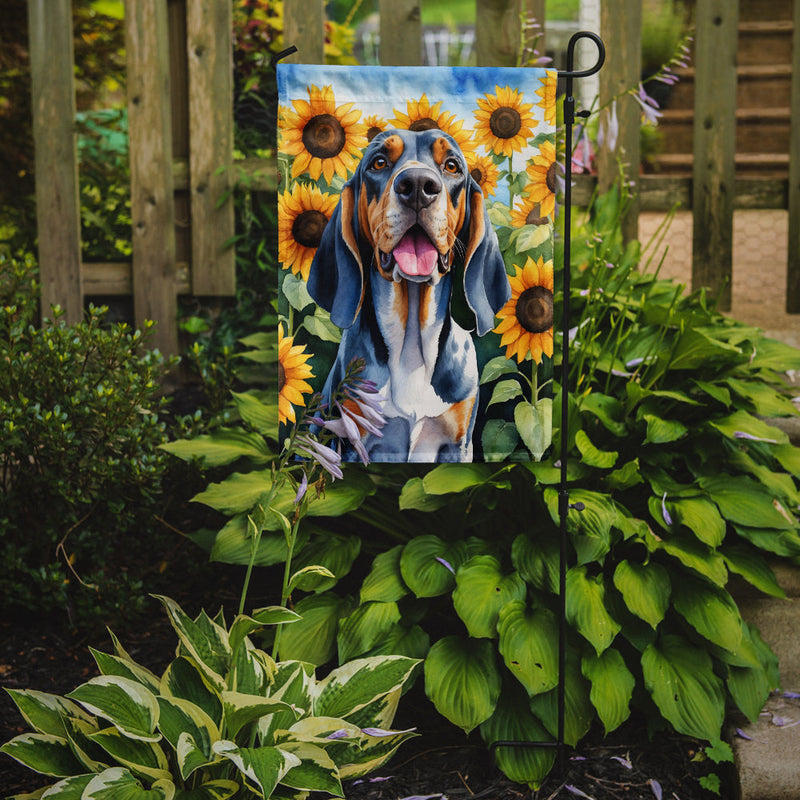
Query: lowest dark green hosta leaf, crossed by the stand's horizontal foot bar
481 684 555 789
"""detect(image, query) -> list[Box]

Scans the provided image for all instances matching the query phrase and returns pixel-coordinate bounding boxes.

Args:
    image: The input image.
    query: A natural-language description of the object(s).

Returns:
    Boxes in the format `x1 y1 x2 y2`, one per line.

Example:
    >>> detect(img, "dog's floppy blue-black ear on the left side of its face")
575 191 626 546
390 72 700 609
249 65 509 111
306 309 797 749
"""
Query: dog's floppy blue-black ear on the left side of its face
307 180 364 328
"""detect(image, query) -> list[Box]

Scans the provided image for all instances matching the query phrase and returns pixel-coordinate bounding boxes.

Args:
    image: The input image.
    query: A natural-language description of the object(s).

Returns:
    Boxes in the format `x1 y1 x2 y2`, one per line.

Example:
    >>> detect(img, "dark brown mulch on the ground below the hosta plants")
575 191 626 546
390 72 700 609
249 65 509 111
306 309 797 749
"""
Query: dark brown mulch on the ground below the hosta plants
0 575 735 800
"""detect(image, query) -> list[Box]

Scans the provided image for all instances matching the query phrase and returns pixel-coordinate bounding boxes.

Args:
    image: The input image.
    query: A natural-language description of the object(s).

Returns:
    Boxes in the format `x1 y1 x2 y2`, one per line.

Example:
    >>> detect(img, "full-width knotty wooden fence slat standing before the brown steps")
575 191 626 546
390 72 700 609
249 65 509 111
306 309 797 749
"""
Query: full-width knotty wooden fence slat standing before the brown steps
692 0 739 311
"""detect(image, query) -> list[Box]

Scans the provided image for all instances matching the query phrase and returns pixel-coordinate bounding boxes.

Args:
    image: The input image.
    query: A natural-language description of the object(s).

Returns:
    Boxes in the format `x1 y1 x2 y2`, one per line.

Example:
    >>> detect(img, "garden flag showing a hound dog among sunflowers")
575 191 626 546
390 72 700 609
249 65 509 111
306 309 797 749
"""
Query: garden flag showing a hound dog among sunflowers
278 64 559 462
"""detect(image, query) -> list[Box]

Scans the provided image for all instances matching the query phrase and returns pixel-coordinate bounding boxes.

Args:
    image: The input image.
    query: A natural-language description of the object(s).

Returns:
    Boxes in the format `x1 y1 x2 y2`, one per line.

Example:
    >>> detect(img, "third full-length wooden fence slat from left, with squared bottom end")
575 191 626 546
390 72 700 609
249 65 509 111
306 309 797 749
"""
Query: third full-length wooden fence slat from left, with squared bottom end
186 0 236 295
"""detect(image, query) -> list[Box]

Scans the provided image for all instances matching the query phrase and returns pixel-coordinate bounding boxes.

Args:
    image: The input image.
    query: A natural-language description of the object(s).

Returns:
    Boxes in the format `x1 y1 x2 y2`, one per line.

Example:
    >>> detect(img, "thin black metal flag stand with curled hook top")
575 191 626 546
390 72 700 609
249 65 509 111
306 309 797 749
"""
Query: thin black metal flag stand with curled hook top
491 31 606 775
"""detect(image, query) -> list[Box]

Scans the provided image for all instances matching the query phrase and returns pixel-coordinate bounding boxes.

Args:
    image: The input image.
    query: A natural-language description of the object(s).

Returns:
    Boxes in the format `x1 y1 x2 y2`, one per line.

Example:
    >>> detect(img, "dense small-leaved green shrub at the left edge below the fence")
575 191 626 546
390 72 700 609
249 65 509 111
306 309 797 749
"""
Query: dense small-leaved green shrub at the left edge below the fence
0 256 174 615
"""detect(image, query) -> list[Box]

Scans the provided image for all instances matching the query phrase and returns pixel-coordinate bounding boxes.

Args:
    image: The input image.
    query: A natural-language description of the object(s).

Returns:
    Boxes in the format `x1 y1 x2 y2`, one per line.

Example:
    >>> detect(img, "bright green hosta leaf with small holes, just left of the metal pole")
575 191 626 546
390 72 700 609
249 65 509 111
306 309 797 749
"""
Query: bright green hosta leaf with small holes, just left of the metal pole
497 600 558 695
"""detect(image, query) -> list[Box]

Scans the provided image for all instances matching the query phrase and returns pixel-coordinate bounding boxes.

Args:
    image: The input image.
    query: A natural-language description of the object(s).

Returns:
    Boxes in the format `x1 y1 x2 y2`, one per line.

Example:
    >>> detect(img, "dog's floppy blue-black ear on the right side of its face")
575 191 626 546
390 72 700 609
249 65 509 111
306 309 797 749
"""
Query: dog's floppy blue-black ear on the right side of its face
464 179 511 336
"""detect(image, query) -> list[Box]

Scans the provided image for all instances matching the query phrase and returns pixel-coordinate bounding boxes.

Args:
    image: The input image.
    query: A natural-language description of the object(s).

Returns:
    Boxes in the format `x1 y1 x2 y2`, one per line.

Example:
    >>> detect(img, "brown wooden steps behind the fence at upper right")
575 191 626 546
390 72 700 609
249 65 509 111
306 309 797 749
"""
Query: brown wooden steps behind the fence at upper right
653 0 794 178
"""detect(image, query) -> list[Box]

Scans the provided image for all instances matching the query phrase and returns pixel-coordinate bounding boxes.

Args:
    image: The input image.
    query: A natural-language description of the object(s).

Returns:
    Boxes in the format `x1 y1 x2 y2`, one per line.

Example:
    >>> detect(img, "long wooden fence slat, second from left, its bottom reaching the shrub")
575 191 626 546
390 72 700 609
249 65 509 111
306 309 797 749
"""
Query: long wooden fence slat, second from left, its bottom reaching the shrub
125 0 178 354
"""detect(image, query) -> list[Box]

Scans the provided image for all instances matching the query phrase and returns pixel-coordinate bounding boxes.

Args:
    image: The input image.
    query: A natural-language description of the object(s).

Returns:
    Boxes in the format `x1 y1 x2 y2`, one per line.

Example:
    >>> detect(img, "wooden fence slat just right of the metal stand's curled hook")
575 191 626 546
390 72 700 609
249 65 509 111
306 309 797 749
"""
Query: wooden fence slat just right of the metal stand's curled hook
588 0 642 241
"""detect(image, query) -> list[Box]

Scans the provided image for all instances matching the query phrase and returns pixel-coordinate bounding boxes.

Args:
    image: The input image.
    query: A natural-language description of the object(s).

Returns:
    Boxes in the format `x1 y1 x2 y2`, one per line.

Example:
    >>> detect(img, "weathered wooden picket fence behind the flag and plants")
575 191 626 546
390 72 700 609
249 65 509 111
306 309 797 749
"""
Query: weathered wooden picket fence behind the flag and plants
29 0 800 353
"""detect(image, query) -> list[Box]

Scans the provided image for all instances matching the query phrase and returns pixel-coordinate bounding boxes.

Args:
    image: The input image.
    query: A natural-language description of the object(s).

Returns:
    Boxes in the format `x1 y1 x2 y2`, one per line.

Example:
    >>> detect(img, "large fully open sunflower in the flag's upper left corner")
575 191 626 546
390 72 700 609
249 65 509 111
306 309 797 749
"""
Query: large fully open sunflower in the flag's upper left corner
279 86 367 184
